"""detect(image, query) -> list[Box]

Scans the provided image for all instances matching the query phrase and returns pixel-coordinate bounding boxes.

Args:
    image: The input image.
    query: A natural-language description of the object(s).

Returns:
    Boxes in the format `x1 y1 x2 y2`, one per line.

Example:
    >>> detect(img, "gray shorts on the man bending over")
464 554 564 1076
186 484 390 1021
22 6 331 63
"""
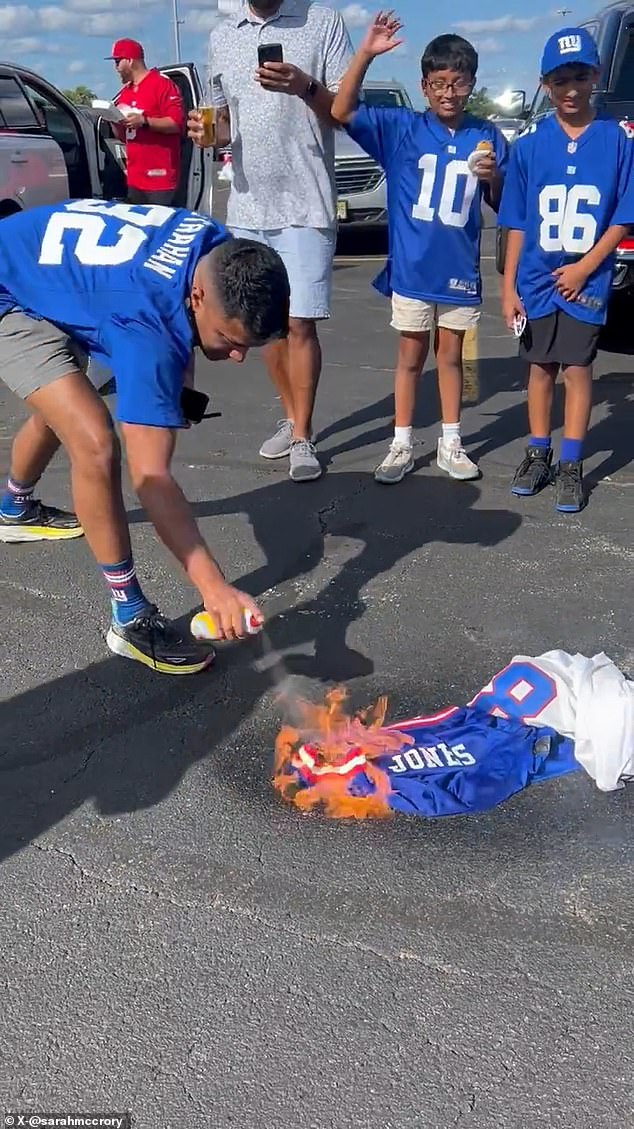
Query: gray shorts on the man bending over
0 309 112 400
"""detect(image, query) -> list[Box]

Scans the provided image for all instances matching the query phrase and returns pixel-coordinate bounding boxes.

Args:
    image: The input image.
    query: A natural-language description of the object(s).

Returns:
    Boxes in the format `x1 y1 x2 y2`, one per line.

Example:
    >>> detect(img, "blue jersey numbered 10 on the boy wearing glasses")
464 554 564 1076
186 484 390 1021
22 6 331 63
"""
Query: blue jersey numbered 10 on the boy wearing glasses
346 105 508 306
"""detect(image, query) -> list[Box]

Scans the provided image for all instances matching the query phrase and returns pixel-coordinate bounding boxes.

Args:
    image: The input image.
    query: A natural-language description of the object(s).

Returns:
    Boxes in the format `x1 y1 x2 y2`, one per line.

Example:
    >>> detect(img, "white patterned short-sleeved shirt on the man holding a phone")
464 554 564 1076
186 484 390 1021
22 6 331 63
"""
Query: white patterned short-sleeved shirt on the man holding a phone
209 0 352 230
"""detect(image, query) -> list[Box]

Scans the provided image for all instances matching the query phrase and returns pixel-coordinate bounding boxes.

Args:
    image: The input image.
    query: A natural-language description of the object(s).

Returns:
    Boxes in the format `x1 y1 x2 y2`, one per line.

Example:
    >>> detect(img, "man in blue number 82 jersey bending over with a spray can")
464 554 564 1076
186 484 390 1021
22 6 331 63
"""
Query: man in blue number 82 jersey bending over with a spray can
0 200 289 675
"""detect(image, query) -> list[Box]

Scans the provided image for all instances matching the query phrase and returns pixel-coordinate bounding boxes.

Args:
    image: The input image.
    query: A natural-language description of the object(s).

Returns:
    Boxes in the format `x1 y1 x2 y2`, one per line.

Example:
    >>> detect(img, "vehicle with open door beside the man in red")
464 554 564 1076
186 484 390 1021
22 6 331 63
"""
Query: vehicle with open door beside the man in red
0 63 213 219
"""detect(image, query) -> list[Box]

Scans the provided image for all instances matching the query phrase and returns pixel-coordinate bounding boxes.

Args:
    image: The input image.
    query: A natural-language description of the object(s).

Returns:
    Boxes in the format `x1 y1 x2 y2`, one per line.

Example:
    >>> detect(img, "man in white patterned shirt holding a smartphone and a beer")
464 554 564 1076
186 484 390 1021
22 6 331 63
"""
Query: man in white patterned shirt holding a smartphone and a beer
188 0 352 482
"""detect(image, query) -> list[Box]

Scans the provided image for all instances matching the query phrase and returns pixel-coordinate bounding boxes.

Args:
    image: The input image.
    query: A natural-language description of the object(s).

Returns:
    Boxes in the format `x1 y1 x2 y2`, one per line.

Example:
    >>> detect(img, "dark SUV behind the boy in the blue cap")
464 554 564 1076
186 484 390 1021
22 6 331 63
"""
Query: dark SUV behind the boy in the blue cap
496 0 634 352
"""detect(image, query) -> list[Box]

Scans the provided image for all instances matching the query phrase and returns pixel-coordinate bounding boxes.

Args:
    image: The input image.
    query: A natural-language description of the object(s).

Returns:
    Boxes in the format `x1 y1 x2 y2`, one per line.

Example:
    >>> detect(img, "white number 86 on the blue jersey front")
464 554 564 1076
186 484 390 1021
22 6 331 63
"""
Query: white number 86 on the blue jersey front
539 184 601 255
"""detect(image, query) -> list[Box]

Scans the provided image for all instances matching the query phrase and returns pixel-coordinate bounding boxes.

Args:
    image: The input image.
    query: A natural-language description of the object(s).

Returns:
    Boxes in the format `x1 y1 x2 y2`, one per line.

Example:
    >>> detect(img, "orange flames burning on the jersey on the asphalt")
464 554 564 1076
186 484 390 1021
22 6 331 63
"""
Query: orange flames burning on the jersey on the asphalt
273 686 414 820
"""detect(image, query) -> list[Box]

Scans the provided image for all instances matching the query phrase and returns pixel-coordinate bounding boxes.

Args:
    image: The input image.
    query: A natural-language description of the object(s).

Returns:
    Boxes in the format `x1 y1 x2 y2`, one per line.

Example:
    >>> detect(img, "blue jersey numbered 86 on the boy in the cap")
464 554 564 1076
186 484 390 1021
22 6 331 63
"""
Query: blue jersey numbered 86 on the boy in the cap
499 115 634 325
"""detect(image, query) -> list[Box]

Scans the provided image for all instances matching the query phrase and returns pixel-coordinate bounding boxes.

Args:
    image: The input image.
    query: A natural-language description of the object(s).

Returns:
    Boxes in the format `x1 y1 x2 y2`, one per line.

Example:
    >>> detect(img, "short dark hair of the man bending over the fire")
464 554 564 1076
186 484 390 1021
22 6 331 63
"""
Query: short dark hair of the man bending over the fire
213 238 290 344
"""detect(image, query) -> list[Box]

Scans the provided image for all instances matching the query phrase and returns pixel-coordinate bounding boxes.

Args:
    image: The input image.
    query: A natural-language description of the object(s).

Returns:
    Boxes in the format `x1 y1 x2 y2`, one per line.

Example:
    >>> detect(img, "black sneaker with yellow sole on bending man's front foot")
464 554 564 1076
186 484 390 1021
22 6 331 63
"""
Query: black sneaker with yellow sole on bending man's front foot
106 605 215 674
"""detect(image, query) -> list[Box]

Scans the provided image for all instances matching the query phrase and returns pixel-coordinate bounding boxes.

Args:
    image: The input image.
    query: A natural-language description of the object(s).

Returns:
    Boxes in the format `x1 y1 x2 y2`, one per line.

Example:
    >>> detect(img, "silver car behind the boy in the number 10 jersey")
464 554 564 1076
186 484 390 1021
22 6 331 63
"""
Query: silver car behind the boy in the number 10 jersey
335 82 413 227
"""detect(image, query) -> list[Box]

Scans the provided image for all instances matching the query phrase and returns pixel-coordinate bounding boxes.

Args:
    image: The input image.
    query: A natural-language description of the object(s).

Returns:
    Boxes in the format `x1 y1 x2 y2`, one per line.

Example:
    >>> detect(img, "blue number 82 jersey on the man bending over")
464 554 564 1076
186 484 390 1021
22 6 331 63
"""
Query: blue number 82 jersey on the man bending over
0 200 229 427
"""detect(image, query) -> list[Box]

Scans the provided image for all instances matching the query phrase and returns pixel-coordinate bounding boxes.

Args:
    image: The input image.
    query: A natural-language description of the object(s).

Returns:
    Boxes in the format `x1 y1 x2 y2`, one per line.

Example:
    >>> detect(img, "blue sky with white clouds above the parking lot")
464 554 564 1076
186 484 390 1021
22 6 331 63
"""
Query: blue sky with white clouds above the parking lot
0 0 601 102
